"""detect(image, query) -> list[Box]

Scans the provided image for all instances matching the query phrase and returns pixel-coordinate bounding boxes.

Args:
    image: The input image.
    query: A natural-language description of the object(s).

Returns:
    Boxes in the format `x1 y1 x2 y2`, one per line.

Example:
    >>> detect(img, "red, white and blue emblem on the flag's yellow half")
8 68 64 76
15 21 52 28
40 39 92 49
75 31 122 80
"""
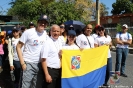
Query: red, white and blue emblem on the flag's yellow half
71 56 81 70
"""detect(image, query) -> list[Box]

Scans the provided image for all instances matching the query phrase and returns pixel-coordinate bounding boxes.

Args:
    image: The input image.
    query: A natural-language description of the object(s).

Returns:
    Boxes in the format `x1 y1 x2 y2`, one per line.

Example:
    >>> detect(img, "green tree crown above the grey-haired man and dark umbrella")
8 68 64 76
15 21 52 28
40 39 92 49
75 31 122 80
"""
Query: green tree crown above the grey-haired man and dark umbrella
46 1 82 24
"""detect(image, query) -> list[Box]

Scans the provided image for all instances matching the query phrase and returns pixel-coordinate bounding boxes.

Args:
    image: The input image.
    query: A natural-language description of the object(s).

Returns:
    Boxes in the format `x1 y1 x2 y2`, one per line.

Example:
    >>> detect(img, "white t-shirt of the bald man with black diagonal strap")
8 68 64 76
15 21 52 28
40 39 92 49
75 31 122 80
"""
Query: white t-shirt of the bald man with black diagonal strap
76 34 94 49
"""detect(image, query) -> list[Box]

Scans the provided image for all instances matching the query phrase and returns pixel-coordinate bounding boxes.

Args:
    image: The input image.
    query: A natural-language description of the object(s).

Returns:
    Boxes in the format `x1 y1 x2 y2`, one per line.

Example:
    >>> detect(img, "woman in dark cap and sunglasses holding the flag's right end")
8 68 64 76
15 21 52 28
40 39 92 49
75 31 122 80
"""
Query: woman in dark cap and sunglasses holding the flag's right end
94 26 112 87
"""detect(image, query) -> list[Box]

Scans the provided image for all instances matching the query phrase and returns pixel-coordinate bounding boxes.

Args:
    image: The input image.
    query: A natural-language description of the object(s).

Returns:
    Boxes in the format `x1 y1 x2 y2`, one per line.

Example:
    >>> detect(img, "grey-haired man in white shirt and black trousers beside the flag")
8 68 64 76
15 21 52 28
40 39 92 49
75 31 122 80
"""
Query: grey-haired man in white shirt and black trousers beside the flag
41 25 62 88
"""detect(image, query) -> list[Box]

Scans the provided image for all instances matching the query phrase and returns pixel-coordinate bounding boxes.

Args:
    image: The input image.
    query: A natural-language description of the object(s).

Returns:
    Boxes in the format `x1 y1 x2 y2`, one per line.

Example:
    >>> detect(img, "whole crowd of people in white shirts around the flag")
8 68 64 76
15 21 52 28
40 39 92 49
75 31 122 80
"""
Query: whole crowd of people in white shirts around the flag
0 15 132 88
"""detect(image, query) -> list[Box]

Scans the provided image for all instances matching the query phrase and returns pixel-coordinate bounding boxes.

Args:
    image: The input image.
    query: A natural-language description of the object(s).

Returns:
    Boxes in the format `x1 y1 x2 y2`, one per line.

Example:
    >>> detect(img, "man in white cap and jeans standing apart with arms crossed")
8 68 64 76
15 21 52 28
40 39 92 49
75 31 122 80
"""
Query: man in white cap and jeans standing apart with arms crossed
115 24 132 77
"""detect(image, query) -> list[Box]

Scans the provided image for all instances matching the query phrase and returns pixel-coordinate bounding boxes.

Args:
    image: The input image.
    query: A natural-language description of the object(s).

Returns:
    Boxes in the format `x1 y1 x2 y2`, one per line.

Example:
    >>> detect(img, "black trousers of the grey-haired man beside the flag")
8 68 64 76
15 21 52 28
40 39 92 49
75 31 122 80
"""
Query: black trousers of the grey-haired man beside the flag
43 67 61 88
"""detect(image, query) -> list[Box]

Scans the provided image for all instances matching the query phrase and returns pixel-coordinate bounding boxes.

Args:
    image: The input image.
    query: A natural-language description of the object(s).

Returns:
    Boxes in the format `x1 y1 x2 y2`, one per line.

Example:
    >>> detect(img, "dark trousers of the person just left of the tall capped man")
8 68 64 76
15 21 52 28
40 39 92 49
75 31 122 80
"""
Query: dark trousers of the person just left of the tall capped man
13 60 21 84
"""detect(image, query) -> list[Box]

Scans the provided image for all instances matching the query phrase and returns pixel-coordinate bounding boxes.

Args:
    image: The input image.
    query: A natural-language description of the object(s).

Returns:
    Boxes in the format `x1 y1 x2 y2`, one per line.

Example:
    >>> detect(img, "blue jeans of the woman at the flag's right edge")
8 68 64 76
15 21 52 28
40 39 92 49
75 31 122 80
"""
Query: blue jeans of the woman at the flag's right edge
104 57 112 84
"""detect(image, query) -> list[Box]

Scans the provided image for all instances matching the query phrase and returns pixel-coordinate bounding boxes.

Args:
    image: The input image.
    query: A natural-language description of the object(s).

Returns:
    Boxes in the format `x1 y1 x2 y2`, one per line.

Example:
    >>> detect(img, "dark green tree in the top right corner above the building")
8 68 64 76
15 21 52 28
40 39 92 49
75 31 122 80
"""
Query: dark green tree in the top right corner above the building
111 0 133 15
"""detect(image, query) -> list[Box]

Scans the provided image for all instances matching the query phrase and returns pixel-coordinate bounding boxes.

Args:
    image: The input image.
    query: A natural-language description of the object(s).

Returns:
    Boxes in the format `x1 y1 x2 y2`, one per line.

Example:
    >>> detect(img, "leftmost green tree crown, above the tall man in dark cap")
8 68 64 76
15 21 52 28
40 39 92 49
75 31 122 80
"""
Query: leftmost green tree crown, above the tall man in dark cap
7 0 45 24
